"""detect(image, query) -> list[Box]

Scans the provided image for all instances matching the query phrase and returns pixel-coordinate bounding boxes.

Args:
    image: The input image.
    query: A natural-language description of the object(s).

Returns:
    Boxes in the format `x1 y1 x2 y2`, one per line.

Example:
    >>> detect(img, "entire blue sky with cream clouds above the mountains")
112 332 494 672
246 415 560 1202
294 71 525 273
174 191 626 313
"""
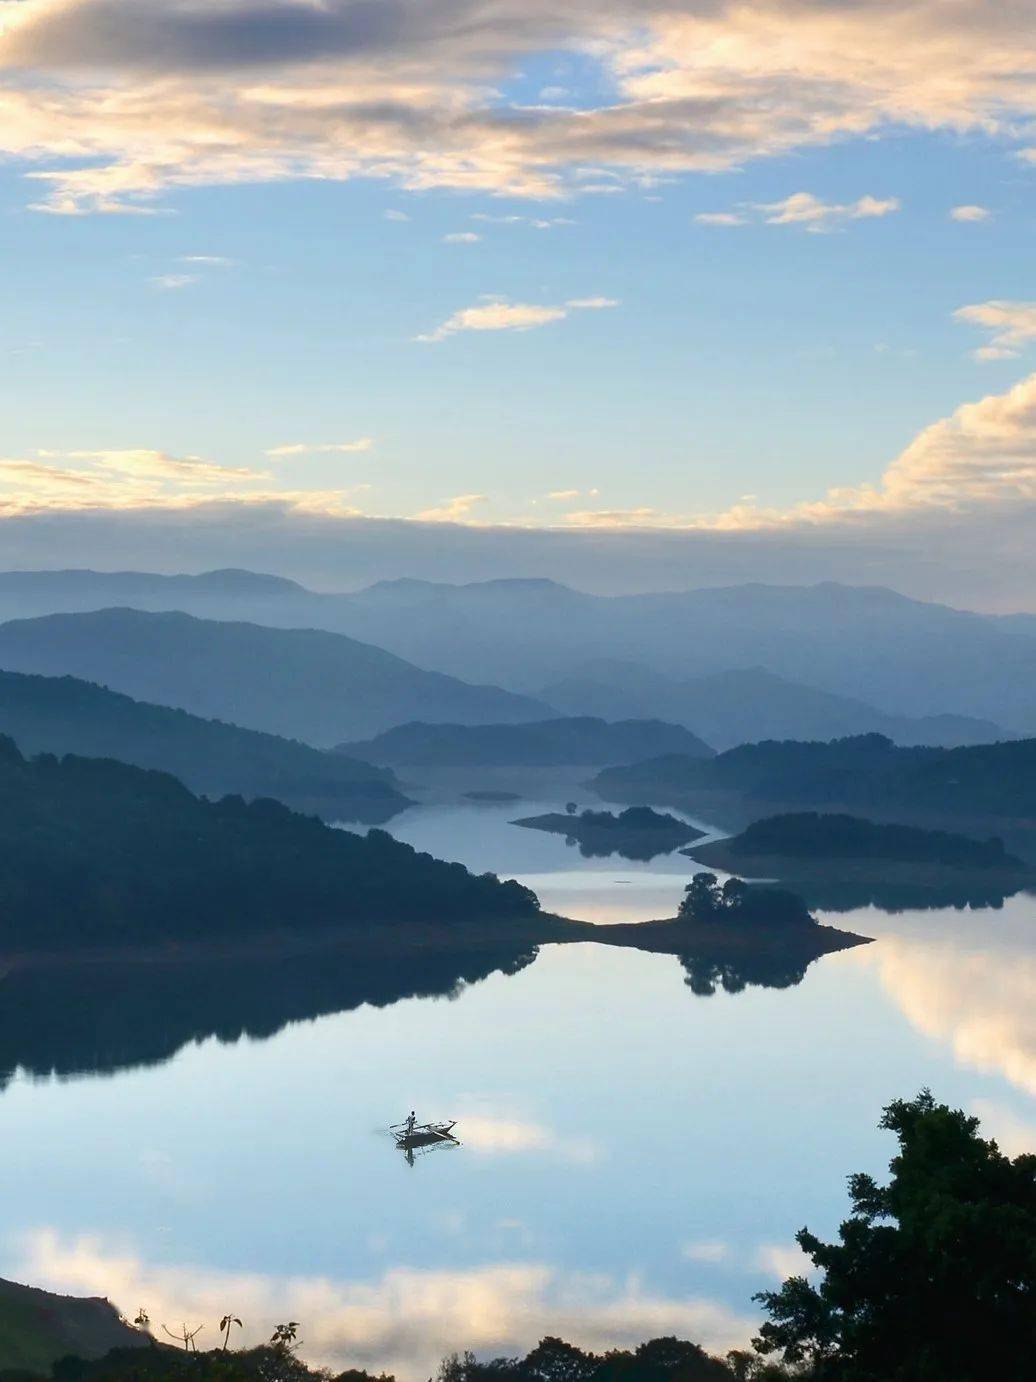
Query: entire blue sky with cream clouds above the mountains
0 0 1036 608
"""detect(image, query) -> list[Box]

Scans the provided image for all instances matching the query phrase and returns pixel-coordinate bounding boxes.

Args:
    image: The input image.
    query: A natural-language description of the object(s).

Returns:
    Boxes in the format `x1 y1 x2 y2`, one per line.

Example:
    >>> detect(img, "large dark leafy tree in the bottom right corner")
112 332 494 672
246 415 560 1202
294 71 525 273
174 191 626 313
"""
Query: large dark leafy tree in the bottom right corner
754 1090 1036 1382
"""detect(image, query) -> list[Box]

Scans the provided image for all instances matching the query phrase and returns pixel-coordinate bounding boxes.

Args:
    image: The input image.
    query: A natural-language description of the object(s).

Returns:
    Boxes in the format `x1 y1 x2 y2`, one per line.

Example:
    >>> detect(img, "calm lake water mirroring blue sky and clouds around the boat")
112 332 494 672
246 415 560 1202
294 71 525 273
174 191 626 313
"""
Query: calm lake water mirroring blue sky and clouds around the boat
0 803 1036 1382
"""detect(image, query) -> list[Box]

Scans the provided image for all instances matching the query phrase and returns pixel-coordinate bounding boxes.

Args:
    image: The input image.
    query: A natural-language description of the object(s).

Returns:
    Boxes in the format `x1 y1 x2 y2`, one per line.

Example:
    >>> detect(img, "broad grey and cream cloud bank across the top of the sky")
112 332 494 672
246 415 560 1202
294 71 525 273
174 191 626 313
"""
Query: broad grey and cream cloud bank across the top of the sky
0 0 1036 214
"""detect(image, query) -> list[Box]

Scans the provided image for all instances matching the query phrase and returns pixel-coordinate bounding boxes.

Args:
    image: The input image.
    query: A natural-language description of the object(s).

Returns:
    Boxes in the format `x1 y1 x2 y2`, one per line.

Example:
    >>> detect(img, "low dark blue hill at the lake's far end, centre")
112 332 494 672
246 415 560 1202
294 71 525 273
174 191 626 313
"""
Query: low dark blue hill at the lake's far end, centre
340 717 713 767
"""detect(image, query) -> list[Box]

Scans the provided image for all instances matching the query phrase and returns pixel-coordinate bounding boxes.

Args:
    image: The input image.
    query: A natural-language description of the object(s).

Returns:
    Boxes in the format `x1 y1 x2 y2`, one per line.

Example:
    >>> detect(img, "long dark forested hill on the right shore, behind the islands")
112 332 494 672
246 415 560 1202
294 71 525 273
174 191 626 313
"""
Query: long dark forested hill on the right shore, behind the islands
594 734 1036 820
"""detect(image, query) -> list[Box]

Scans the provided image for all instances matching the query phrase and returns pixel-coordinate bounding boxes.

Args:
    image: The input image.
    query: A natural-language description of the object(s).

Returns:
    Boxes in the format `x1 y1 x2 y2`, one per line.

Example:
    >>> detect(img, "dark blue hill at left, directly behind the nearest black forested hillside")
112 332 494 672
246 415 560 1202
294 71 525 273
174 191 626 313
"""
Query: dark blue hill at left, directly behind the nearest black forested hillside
0 672 407 824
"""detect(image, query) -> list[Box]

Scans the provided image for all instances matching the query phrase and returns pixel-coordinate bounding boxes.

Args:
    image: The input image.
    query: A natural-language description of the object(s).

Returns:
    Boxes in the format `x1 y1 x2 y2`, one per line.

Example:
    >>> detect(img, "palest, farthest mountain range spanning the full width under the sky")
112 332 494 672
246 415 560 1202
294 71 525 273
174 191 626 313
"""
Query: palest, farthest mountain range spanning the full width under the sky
0 572 1036 738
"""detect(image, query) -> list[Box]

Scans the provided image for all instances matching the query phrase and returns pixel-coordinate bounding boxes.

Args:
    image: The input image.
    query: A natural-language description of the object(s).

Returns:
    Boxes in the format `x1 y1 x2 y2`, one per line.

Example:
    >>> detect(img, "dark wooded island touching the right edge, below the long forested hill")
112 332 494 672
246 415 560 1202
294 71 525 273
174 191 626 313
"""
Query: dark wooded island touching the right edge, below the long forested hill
684 811 1036 891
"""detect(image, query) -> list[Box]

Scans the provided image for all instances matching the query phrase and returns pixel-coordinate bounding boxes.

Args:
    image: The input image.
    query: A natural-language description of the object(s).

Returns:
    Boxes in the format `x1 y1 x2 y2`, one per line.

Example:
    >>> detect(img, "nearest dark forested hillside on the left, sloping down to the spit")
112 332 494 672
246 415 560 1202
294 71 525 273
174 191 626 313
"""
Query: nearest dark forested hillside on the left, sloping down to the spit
0 737 539 954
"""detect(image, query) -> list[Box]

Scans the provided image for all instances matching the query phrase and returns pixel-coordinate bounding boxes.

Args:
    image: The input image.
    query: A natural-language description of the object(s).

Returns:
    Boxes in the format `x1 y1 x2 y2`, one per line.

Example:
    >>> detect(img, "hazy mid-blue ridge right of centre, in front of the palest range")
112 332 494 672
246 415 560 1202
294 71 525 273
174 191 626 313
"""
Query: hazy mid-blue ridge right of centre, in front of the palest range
540 659 1014 749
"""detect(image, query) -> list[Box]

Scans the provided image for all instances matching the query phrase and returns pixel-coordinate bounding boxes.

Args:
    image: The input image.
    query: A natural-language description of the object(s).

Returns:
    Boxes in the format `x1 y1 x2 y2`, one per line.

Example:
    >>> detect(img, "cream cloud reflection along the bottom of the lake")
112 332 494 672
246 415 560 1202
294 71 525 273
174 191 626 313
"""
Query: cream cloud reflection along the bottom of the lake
8 1229 753 1379
